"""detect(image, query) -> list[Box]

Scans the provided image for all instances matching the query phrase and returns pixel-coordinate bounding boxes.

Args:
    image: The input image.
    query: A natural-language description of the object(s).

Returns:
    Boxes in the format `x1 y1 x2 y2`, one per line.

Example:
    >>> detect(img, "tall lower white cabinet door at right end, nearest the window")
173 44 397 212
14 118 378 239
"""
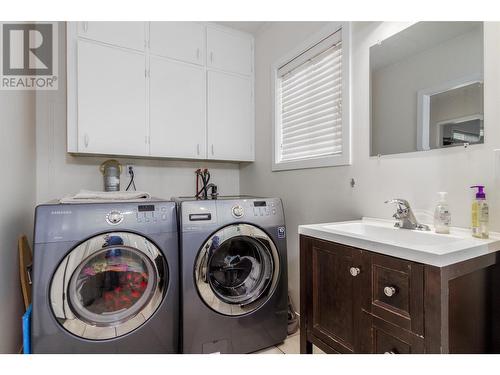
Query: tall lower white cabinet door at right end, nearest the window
208 72 255 161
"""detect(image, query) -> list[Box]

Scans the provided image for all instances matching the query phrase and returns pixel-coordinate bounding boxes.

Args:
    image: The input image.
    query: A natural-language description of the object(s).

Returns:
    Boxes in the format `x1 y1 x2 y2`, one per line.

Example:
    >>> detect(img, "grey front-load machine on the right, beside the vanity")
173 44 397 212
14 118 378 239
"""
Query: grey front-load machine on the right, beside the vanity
174 197 288 353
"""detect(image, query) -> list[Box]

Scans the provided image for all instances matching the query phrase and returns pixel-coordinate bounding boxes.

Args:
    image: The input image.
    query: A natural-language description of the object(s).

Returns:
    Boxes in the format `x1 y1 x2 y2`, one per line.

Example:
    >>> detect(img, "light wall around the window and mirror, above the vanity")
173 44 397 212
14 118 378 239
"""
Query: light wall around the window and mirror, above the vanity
240 22 500 304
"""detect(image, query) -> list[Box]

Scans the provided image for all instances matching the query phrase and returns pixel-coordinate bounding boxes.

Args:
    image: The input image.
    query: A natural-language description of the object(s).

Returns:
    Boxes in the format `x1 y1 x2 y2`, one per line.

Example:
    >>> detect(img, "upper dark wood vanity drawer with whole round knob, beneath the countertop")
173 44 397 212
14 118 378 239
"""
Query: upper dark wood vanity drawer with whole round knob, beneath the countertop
363 253 424 335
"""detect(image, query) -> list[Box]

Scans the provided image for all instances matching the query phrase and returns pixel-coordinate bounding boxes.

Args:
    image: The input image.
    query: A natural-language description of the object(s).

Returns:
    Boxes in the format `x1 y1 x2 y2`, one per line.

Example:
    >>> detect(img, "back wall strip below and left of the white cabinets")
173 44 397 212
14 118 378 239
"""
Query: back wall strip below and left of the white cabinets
36 23 239 203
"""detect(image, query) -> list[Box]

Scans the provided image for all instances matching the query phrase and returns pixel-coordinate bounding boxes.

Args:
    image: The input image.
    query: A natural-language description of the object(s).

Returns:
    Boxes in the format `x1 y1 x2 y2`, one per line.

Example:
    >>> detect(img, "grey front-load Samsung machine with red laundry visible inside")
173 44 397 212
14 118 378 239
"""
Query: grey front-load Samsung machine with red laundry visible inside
31 201 179 353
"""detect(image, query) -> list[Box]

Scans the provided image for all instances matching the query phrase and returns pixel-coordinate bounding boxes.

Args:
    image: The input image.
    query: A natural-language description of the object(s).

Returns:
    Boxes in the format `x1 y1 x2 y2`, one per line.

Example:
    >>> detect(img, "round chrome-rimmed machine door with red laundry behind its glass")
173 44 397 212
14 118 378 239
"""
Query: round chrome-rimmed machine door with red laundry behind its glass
50 232 168 340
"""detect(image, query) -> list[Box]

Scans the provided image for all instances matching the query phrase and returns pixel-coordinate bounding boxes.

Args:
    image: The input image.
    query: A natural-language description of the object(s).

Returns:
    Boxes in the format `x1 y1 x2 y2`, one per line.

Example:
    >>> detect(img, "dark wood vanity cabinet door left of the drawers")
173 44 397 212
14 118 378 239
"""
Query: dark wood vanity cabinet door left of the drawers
301 239 363 353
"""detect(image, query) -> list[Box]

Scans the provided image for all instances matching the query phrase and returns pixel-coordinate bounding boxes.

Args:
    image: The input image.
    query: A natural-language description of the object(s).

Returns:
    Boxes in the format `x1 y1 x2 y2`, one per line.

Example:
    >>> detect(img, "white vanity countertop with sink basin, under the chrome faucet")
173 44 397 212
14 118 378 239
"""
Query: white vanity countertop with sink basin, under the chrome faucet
299 218 500 267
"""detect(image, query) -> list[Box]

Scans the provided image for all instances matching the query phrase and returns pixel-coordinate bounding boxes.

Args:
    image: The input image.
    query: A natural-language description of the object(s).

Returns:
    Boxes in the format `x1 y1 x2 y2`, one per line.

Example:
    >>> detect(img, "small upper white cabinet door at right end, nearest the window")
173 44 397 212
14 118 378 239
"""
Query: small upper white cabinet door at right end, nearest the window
207 27 253 75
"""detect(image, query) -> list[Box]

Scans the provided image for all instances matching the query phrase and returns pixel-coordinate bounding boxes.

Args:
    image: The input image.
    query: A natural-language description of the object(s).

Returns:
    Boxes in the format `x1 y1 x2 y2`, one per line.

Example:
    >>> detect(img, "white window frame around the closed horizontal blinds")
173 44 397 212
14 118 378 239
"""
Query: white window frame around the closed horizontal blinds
271 22 351 172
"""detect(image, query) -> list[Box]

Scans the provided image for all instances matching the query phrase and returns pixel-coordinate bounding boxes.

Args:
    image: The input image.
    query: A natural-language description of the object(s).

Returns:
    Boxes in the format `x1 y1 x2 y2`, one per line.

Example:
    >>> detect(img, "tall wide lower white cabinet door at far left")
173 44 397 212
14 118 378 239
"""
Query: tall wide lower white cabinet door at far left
77 40 147 155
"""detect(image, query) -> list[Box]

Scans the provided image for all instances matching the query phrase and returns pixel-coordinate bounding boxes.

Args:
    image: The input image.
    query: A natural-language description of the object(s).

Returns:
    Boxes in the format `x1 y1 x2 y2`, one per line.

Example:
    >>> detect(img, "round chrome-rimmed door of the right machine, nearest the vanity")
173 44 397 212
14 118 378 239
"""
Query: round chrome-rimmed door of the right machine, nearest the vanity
194 224 280 316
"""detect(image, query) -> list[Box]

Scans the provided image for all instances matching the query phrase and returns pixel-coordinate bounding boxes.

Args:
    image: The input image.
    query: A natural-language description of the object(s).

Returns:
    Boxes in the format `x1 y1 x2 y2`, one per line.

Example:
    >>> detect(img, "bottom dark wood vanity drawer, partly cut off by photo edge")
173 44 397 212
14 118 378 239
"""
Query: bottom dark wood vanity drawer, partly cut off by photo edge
364 313 425 354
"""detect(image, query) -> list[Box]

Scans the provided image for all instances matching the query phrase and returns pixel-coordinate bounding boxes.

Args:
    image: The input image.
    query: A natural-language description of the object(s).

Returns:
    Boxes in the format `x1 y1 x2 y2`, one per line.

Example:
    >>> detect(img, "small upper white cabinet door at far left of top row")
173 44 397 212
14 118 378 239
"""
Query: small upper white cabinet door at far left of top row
78 21 146 51
